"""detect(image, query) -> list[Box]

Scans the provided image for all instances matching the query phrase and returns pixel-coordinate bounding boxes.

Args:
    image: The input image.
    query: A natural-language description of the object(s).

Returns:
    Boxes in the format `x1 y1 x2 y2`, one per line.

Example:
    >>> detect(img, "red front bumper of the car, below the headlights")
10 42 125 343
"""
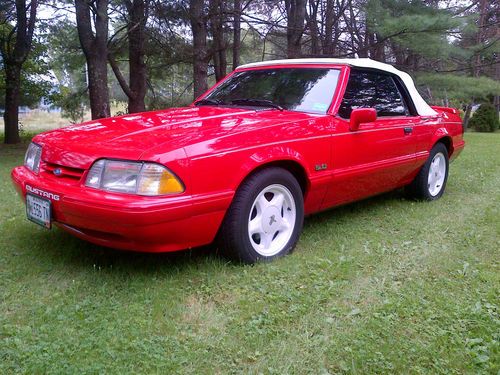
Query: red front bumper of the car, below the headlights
11 166 234 252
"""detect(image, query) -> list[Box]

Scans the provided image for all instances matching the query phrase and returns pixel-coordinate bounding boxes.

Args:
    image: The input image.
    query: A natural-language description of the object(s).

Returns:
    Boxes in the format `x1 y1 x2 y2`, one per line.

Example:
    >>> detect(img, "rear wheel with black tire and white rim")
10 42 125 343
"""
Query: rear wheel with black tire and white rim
406 143 449 201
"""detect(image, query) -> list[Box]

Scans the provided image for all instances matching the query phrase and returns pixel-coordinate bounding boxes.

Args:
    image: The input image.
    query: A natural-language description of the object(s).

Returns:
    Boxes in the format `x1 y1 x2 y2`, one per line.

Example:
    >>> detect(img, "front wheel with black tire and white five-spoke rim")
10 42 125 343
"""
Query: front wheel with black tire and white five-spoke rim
218 167 304 264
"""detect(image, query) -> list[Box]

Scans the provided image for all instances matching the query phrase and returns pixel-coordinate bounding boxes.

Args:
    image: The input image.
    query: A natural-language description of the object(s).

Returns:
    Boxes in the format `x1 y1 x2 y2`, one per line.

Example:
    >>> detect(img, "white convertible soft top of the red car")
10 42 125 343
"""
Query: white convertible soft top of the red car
238 58 437 116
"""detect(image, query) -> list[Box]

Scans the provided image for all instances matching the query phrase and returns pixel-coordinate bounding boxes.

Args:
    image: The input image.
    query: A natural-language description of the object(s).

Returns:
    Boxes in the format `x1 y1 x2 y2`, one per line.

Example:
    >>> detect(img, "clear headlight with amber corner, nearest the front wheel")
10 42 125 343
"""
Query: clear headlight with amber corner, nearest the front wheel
85 159 184 195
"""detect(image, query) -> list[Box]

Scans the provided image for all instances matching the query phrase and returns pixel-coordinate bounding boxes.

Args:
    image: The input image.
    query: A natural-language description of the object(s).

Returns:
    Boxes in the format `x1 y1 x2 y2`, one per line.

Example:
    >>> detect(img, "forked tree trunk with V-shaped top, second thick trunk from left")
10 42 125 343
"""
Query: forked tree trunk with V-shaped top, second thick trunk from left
75 0 110 119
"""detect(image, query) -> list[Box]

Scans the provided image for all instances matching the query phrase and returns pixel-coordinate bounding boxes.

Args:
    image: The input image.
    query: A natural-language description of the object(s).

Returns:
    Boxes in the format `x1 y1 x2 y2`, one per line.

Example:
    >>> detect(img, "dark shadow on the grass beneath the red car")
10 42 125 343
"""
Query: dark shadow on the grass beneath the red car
18 190 404 273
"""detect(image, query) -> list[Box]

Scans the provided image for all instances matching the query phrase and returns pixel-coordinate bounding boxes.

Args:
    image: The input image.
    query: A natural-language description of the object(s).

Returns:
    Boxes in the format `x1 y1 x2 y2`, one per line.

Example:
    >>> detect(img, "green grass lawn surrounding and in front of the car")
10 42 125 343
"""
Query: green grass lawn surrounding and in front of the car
0 133 500 374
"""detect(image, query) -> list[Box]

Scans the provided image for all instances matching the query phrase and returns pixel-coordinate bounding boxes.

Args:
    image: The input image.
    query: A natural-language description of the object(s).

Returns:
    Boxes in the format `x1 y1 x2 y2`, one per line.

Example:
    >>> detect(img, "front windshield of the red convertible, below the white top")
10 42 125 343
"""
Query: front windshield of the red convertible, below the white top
202 68 340 114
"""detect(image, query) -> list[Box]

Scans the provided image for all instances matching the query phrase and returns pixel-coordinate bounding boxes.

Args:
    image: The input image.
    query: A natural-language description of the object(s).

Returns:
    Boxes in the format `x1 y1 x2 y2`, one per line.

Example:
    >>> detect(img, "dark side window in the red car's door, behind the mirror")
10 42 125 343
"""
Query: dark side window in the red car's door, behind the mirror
338 69 409 119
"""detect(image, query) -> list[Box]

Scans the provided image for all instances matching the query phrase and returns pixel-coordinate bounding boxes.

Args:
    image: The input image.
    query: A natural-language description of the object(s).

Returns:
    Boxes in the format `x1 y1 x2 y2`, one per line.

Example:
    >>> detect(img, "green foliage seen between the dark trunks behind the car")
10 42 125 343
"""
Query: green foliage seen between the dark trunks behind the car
0 0 500 125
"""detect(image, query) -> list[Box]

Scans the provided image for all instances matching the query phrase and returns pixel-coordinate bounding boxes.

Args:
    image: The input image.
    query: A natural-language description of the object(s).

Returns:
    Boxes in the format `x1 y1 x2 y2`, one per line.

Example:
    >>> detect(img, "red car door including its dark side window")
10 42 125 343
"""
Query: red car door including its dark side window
323 68 419 208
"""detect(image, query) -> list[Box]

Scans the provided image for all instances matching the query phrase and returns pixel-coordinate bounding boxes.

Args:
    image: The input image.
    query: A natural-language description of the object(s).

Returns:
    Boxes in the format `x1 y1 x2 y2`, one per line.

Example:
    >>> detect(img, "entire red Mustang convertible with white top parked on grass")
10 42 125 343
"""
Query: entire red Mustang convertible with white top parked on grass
12 59 464 263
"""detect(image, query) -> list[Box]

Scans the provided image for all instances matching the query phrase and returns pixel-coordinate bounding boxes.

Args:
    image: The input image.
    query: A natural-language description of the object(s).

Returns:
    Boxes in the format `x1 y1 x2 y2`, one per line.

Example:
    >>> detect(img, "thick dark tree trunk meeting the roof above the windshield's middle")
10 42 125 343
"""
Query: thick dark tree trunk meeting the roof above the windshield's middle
285 0 307 59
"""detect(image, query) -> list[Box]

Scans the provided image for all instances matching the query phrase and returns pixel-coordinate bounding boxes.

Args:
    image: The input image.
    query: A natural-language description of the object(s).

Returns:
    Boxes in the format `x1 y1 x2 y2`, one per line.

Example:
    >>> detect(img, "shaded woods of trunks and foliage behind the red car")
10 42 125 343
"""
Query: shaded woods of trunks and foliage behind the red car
0 0 500 143
